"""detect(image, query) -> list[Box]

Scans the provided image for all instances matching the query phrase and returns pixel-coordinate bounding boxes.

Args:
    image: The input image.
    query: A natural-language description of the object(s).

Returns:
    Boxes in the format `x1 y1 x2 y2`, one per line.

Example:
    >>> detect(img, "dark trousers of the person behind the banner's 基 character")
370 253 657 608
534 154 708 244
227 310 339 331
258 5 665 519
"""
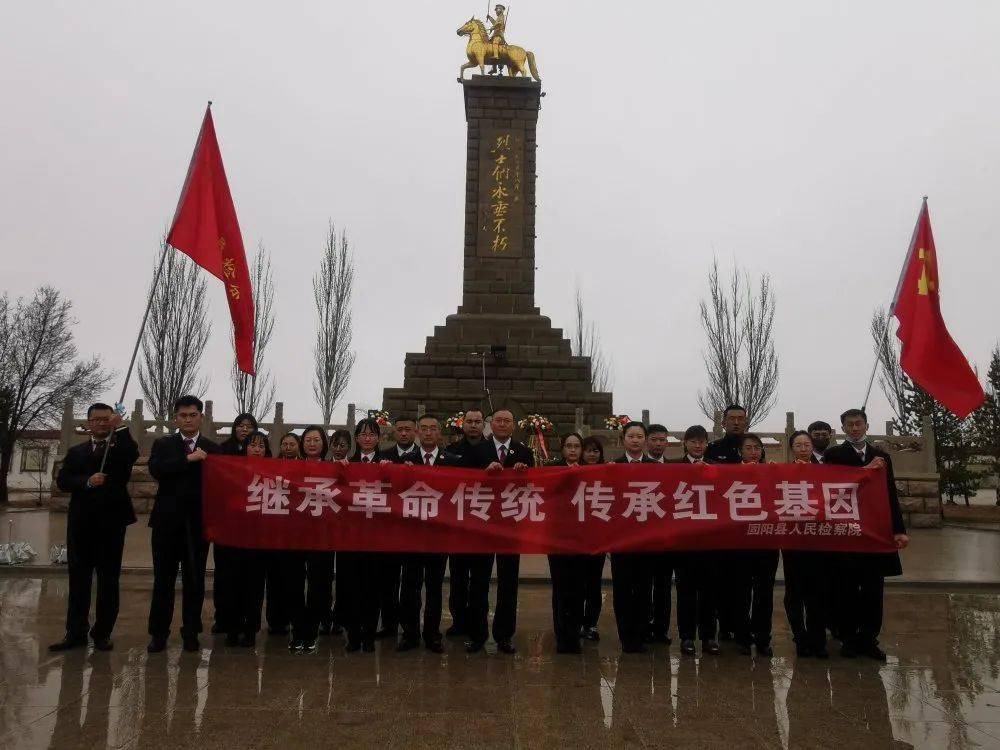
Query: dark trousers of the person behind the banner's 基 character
781 550 832 649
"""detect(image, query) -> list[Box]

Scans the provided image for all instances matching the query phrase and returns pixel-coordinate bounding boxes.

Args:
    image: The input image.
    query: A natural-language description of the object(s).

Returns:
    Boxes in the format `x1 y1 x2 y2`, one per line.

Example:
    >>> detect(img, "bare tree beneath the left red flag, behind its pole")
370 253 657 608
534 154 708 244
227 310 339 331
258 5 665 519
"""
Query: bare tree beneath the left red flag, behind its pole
139 240 212 418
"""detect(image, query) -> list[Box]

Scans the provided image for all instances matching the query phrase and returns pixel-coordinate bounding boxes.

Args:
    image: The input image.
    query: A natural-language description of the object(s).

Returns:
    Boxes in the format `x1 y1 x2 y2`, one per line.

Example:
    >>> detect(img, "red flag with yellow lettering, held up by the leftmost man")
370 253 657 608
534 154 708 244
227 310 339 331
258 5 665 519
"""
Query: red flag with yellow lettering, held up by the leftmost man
167 102 254 375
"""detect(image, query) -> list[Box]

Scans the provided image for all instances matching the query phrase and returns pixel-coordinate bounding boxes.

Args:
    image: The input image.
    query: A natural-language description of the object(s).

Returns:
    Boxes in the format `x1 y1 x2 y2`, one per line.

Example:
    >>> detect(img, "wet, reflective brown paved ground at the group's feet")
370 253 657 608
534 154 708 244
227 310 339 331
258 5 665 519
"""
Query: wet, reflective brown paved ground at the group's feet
0 574 1000 750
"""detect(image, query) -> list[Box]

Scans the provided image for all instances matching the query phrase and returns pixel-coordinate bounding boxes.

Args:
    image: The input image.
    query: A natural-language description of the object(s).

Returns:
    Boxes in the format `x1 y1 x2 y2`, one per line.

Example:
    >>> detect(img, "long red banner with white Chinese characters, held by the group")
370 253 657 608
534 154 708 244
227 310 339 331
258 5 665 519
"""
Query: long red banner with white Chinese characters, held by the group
203 456 896 554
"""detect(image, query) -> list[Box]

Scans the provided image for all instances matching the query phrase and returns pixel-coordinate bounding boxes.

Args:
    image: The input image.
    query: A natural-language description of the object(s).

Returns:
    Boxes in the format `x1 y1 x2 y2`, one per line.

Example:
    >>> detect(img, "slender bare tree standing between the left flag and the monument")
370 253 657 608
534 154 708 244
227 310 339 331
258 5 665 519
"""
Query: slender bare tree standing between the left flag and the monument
313 222 355 424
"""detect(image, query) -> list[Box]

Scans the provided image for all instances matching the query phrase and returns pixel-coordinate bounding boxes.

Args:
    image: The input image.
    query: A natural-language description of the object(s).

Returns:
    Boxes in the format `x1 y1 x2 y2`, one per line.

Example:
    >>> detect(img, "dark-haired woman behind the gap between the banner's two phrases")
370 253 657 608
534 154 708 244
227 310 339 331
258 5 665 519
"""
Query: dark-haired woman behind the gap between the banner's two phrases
548 432 590 654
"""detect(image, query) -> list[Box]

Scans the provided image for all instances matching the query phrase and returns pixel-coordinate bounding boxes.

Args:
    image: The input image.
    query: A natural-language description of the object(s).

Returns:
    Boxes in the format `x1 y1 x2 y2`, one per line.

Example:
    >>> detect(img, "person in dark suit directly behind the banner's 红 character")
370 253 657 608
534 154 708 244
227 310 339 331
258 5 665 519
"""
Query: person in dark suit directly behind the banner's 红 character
672 424 720 656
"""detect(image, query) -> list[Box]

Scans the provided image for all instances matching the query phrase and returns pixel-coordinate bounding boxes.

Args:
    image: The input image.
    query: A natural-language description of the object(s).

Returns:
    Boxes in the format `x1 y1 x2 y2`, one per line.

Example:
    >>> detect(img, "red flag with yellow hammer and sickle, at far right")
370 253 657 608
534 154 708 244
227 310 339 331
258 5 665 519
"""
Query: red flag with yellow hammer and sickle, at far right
892 198 985 419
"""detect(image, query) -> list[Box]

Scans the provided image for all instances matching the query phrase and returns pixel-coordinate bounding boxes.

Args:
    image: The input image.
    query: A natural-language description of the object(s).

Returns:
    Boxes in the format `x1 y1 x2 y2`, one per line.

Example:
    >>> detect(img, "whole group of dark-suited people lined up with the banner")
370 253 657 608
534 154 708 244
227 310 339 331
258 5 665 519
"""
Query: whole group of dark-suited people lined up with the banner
50 396 908 660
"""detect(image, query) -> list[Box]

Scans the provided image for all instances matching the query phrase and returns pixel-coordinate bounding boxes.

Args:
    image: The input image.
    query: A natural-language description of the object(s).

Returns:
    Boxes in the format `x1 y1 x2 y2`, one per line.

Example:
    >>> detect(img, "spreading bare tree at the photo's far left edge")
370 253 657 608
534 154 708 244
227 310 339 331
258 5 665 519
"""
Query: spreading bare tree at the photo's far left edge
0 286 111 503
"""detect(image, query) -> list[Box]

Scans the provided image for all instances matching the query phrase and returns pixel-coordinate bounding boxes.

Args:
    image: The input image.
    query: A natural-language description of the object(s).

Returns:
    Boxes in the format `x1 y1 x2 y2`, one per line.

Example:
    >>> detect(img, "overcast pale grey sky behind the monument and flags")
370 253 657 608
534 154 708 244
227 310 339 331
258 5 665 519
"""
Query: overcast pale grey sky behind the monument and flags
0 0 1000 429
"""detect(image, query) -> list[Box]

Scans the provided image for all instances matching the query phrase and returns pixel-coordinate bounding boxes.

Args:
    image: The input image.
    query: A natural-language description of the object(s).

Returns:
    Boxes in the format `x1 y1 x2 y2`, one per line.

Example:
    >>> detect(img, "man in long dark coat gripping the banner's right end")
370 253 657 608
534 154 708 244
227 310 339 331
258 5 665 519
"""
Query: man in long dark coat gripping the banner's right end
823 409 910 661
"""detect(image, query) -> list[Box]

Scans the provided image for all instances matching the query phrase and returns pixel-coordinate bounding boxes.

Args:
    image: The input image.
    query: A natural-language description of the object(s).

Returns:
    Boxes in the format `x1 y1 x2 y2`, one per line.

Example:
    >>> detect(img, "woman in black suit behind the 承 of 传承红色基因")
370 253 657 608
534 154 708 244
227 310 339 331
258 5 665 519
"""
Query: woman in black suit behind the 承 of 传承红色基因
611 422 657 654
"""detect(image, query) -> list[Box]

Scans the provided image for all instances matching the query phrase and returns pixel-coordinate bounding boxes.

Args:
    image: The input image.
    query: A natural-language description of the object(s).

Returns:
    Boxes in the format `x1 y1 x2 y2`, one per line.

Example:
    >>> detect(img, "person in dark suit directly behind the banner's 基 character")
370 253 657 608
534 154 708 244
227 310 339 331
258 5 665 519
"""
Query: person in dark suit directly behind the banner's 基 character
781 430 830 659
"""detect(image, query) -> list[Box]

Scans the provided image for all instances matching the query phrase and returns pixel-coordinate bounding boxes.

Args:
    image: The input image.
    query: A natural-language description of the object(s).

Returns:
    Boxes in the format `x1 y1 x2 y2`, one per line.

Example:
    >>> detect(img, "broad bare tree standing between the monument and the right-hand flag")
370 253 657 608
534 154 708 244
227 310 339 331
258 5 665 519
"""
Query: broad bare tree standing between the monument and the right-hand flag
698 261 778 425
